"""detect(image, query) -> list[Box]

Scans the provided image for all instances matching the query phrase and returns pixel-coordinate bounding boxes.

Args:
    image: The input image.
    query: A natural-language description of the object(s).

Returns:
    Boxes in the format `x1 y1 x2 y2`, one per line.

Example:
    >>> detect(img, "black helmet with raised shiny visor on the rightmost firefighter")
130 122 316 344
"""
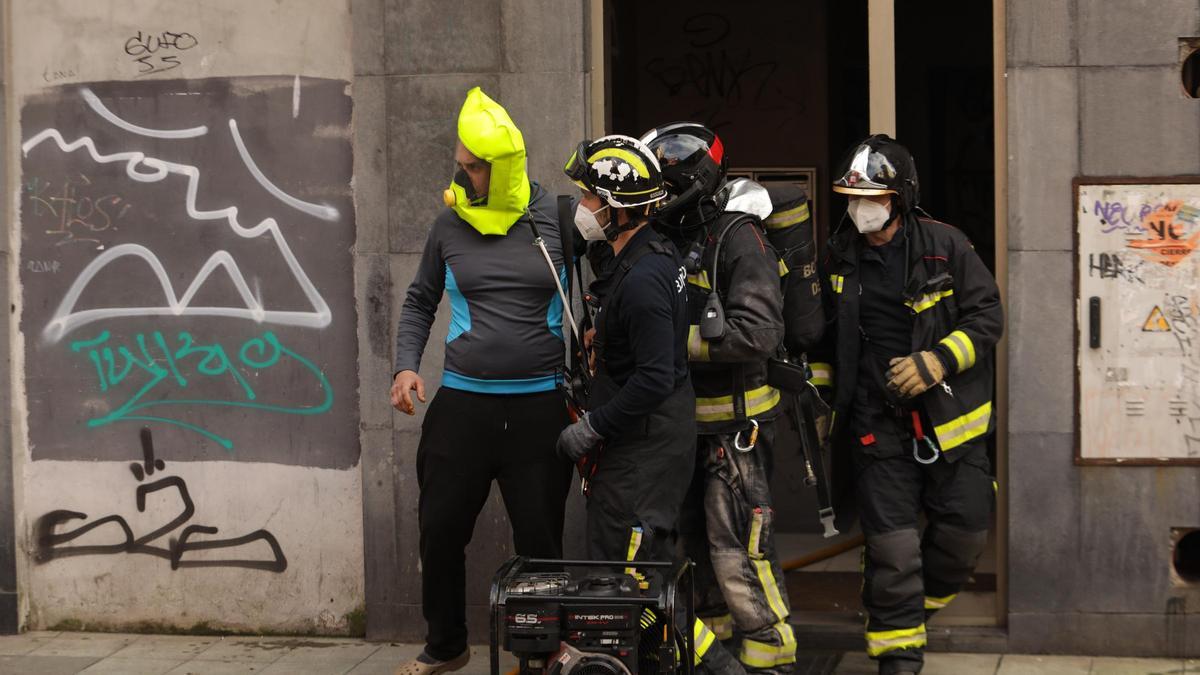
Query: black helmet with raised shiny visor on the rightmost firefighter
833 133 920 214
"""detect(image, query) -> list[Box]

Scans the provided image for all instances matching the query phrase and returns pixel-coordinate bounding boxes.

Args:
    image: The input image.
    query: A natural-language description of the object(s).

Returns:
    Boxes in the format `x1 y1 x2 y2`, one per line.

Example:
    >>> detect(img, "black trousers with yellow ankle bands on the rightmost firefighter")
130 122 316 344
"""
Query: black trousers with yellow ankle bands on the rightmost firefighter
852 389 996 674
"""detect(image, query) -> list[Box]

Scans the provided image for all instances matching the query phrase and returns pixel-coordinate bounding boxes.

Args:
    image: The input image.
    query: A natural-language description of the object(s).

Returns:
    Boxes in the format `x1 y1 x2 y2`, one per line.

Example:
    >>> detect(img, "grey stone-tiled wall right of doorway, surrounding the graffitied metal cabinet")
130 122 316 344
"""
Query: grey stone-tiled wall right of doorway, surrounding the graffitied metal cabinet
1007 0 1200 656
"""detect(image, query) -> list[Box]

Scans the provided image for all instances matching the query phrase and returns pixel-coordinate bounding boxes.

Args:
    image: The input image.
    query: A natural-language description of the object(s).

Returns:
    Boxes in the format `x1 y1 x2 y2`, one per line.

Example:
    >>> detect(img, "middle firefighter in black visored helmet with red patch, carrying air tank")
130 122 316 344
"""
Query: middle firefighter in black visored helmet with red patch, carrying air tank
642 123 796 673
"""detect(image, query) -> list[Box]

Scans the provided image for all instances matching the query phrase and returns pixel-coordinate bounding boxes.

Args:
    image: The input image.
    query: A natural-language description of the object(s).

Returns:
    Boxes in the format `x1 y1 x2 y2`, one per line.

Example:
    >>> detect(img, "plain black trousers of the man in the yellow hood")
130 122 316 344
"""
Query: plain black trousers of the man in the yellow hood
416 387 571 661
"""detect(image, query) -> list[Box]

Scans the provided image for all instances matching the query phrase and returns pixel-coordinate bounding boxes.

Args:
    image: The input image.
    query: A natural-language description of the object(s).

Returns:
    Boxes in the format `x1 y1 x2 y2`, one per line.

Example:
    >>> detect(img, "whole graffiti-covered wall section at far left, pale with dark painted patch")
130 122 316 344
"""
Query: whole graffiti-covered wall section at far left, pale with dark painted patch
0 0 364 633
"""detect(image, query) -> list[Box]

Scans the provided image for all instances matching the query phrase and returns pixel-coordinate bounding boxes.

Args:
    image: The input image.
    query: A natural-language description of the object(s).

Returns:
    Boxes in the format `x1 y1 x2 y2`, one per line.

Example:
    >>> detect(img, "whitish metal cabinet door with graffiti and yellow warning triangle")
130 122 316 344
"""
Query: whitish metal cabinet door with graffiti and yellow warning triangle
1074 177 1200 465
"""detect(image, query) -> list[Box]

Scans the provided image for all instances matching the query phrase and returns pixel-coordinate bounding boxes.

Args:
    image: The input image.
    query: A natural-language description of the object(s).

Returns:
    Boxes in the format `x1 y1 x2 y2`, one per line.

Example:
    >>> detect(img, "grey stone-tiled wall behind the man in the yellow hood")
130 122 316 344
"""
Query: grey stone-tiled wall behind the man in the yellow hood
352 0 587 640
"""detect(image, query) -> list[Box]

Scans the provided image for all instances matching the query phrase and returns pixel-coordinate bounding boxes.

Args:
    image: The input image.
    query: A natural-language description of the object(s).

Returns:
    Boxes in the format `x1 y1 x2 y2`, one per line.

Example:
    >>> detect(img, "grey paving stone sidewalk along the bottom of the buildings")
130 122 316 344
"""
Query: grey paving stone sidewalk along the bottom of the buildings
0 632 1200 675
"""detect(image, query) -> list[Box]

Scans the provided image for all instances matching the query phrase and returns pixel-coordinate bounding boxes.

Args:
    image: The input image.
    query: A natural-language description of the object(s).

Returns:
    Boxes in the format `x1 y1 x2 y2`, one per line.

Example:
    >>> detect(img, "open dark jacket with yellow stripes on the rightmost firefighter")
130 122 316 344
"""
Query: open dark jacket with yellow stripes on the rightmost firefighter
812 213 1004 460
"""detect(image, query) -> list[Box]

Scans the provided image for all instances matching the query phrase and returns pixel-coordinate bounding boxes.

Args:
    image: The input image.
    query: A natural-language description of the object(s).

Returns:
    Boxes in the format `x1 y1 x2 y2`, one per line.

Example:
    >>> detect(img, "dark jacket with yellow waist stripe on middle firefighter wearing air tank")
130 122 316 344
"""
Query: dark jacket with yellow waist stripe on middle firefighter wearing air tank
688 213 784 434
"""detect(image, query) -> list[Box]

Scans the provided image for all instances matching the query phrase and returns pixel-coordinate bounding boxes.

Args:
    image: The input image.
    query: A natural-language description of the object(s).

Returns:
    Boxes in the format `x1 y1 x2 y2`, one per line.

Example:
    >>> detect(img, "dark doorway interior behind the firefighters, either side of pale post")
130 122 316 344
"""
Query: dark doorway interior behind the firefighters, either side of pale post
605 0 995 632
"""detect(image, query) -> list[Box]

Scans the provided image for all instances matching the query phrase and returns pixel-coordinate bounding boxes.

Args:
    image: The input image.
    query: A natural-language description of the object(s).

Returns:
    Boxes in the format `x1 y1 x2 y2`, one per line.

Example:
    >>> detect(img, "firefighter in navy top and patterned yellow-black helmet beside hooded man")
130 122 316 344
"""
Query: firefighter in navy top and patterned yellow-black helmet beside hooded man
558 136 740 675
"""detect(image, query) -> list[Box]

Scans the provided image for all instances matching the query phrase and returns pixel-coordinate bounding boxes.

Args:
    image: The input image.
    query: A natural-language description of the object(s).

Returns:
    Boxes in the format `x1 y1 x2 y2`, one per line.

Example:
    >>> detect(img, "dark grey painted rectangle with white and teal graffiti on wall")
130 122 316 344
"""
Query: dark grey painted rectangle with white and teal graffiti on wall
20 77 359 468
